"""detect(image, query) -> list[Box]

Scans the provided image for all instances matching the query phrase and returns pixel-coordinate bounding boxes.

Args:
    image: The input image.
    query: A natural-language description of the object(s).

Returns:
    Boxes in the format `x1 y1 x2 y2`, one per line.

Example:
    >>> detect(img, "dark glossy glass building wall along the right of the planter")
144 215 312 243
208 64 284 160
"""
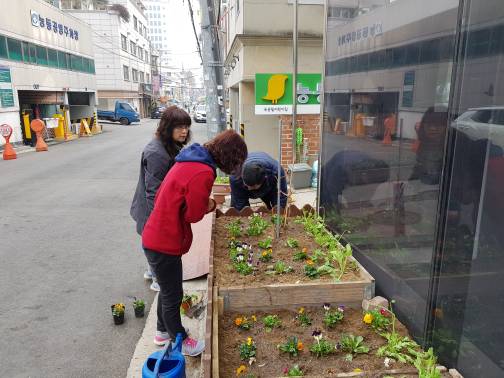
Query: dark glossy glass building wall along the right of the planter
320 0 504 378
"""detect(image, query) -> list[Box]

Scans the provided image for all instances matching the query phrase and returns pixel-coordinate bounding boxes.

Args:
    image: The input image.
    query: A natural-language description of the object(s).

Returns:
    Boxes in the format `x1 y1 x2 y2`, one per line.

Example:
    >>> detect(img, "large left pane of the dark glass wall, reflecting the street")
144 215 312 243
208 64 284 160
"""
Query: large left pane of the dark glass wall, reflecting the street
320 0 459 341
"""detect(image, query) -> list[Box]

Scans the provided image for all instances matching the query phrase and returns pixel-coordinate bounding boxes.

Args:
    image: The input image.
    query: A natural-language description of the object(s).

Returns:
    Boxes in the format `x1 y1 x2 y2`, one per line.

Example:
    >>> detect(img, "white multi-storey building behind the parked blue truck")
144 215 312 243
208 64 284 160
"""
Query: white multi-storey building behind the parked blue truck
61 0 154 117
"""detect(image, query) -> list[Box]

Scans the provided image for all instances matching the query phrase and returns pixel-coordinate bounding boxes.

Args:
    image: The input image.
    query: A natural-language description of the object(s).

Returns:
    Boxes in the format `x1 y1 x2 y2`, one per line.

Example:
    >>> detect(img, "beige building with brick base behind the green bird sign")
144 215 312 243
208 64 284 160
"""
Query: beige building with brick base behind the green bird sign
220 0 385 166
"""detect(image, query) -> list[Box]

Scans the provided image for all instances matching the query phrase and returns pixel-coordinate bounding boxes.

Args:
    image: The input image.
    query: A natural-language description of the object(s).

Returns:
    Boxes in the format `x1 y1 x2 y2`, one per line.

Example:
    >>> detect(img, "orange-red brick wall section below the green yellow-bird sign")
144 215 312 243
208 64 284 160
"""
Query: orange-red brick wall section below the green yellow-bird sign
280 114 320 168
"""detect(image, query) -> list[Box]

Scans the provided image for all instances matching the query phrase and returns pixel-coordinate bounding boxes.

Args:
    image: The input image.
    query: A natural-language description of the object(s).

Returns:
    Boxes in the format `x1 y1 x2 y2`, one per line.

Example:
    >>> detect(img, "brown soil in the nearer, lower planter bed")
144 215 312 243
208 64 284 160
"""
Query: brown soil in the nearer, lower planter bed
219 308 415 377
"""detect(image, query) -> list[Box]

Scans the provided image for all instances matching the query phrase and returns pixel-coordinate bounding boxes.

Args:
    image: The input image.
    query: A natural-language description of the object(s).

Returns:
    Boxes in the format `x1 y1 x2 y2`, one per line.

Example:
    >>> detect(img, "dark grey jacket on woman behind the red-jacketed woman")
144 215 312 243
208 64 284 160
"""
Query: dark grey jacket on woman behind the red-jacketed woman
130 138 179 235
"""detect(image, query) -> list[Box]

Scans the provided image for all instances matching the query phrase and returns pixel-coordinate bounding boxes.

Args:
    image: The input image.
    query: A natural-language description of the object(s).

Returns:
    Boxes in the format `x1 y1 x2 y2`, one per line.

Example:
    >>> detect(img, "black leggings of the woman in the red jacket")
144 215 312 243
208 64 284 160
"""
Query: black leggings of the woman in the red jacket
144 249 187 340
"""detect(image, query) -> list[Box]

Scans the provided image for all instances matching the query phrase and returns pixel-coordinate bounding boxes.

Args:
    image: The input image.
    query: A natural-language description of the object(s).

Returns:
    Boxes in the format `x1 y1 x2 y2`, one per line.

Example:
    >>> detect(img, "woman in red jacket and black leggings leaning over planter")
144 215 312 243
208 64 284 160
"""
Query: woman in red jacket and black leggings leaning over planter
142 130 247 356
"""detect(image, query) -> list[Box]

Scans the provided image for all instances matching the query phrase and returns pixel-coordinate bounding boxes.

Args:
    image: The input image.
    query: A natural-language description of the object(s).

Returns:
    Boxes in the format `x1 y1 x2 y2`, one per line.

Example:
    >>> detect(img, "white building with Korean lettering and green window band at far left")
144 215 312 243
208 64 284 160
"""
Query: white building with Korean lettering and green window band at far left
0 0 96 144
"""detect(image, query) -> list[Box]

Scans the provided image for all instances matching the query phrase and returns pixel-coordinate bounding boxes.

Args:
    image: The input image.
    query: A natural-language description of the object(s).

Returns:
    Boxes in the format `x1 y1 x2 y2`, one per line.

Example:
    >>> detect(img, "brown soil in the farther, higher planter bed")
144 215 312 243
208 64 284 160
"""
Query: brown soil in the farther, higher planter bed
214 216 361 287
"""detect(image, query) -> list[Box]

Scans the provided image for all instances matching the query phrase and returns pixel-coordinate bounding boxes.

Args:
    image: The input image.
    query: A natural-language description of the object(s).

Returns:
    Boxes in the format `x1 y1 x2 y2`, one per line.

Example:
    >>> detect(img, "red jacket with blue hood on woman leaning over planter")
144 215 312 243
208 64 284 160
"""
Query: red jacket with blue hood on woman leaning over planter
142 143 215 256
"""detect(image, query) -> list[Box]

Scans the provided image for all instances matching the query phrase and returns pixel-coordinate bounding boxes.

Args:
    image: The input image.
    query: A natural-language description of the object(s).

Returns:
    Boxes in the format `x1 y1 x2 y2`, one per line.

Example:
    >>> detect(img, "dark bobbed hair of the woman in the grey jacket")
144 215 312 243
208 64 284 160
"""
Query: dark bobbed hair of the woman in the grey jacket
156 105 191 158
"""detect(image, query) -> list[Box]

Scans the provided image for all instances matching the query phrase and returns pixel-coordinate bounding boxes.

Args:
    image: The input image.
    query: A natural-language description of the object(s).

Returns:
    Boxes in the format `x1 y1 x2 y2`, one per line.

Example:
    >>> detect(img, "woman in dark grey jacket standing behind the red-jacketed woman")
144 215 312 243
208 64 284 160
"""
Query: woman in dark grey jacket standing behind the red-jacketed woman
130 106 191 291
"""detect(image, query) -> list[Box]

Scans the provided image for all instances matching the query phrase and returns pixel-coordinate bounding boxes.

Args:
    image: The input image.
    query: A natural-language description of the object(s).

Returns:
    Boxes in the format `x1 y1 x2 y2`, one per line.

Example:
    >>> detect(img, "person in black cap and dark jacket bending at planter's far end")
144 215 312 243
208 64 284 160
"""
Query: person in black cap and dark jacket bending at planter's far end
230 152 287 210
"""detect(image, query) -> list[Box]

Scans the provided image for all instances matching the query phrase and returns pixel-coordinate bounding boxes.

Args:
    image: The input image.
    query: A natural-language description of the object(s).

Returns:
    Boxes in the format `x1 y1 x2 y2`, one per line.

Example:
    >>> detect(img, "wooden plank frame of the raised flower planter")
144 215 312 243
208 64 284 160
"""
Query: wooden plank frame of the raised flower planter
203 206 375 377
